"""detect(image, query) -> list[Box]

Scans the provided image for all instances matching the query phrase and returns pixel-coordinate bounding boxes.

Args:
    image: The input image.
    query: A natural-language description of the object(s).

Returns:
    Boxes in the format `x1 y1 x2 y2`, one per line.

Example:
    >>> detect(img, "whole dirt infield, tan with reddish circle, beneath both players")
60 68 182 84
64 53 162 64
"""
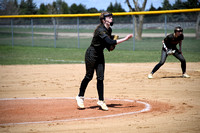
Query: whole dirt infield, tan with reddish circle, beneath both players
0 62 200 133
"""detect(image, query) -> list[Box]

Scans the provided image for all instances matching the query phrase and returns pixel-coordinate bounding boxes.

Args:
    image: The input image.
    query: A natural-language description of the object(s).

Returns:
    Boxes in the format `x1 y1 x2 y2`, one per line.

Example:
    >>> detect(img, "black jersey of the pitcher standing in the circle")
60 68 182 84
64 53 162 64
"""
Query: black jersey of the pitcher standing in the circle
91 24 116 52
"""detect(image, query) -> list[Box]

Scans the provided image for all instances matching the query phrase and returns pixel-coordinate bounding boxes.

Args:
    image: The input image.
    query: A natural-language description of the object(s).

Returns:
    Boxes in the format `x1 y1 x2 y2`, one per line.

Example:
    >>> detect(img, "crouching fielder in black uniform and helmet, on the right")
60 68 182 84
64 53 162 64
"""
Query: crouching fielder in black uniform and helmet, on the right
148 26 190 79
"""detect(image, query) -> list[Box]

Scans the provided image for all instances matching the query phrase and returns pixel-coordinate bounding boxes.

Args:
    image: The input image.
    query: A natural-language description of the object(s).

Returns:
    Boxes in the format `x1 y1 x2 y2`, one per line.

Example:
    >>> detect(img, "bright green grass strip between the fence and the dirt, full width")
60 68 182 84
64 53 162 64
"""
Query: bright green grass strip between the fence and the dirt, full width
0 46 200 65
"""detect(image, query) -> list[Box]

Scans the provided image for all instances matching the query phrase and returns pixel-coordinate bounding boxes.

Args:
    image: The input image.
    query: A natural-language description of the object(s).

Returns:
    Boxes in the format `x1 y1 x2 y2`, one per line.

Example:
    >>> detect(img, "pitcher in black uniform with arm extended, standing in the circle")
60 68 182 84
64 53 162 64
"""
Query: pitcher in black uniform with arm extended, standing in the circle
76 12 133 110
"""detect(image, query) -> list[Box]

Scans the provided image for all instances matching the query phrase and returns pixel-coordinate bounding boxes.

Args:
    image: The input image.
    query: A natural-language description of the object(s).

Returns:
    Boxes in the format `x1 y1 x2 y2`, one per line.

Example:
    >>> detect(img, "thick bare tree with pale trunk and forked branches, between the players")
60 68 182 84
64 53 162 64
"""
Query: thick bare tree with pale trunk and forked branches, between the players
126 0 147 40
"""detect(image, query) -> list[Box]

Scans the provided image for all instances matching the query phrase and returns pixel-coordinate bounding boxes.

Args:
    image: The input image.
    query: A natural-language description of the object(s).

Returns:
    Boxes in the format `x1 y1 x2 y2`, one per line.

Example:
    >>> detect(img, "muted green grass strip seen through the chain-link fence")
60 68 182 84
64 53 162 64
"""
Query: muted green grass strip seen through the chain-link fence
0 36 200 52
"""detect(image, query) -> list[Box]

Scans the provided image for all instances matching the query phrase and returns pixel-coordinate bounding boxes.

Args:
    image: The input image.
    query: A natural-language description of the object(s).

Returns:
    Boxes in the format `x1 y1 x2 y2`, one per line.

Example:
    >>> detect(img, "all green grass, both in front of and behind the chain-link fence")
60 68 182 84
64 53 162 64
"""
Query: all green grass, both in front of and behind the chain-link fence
0 28 200 65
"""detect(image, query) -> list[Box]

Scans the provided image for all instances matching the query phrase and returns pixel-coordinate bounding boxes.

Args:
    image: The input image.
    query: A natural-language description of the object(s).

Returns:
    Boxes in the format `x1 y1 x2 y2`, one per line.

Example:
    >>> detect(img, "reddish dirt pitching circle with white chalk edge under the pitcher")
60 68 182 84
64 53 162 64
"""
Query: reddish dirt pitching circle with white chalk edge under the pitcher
0 98 169 125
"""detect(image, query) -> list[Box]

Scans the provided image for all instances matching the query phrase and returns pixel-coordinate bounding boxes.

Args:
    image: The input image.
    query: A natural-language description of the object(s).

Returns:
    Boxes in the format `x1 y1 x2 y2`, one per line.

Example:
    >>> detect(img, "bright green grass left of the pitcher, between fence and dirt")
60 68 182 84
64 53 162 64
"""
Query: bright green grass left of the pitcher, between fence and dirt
0 46 84 65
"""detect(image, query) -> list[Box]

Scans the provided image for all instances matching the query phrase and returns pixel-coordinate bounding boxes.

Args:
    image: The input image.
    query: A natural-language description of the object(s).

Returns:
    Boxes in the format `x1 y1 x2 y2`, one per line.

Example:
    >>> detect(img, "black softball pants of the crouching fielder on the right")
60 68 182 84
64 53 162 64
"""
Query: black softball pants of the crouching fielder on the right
151 49 186 74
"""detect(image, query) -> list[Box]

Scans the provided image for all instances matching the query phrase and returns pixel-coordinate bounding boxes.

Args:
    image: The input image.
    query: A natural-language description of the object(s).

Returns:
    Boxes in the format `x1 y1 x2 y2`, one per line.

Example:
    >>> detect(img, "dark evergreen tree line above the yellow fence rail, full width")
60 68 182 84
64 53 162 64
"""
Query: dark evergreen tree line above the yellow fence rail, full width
0 0 200 15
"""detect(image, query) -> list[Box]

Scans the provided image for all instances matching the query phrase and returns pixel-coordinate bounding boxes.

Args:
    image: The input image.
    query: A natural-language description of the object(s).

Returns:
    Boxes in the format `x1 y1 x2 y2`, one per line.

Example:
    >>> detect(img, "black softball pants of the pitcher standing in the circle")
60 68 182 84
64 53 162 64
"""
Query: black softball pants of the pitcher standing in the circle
79 46 105 101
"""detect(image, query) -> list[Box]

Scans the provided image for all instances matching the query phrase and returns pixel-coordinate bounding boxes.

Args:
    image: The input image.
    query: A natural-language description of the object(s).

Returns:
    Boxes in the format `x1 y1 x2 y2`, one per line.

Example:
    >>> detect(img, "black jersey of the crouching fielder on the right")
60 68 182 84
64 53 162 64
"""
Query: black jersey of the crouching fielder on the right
164 33 184 49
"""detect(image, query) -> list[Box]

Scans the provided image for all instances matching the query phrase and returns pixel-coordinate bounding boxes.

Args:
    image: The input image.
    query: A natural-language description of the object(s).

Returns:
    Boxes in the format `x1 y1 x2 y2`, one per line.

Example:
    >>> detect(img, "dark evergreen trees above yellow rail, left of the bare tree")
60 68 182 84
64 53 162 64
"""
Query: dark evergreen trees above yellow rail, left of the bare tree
0 0 125 15
